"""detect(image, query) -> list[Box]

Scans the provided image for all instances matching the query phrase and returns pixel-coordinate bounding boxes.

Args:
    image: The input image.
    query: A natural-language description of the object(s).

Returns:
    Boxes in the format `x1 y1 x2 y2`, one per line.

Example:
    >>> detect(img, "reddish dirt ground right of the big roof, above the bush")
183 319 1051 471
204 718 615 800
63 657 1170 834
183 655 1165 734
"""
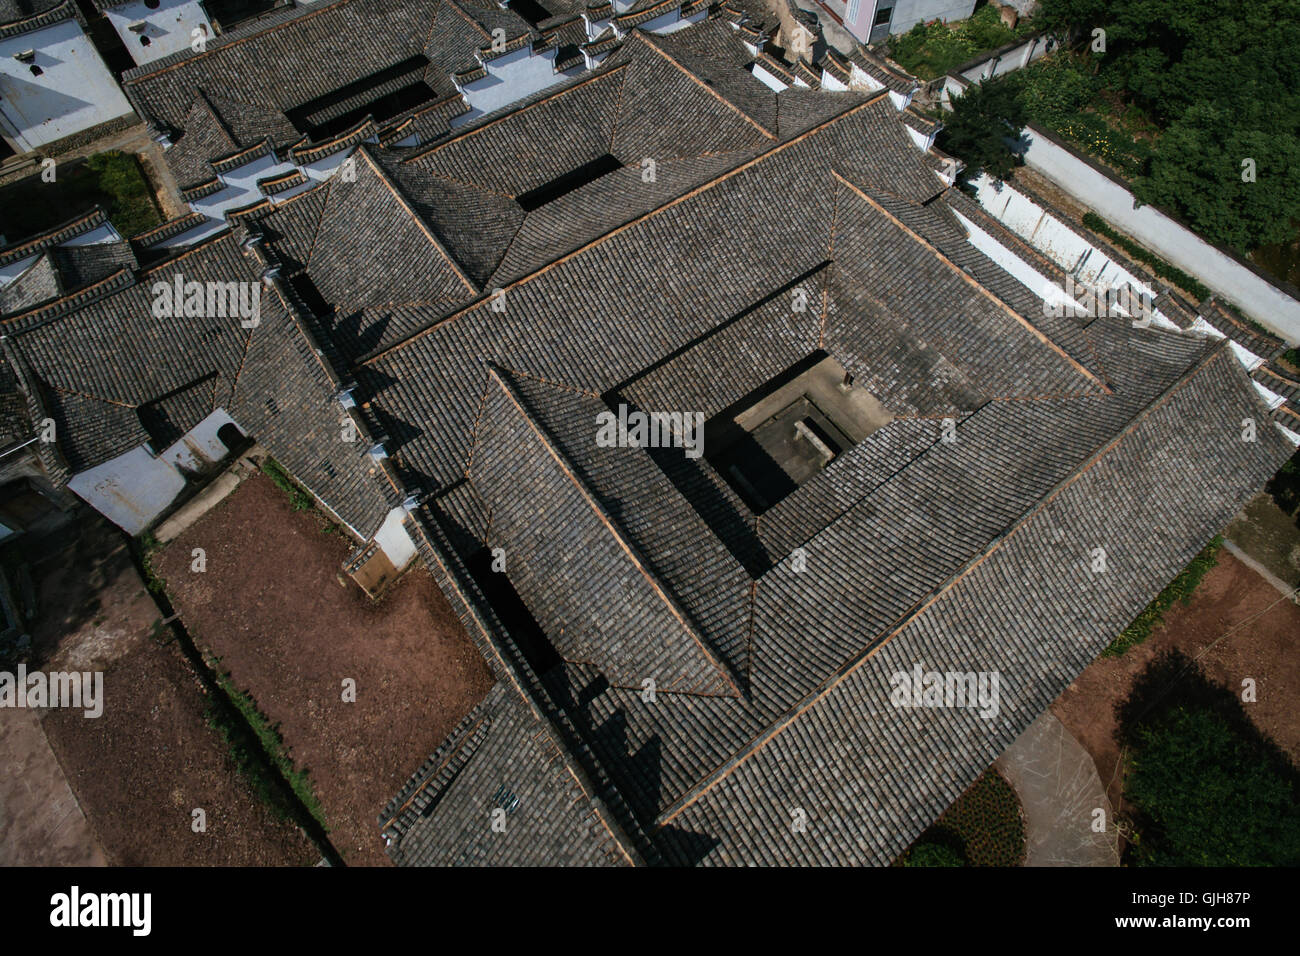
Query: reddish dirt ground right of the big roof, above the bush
1052 550 1300 810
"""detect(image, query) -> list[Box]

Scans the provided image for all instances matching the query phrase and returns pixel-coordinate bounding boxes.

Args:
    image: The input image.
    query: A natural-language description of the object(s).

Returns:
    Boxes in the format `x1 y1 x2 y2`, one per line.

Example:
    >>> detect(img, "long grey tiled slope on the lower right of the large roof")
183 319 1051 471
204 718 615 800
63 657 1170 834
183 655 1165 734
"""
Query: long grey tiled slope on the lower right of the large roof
662 349 1284 865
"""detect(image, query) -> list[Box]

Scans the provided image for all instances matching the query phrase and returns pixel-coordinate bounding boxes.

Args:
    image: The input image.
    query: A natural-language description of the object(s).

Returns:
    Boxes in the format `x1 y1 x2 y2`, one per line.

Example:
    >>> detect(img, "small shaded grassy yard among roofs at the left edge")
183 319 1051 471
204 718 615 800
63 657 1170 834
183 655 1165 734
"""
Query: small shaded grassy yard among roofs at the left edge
0 151 163 241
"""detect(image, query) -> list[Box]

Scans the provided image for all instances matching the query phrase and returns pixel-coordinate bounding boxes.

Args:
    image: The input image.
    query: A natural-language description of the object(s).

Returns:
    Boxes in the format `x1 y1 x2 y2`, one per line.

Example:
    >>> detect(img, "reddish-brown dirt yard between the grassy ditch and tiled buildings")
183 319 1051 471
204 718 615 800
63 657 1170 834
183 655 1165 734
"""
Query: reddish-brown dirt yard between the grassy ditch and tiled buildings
155 473 491 865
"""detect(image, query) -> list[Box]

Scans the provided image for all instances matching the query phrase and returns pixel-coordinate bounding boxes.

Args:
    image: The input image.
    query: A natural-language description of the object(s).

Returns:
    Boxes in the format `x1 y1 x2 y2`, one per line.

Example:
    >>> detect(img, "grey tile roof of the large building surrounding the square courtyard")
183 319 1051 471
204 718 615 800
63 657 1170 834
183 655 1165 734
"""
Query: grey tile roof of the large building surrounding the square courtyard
340 34 1290 862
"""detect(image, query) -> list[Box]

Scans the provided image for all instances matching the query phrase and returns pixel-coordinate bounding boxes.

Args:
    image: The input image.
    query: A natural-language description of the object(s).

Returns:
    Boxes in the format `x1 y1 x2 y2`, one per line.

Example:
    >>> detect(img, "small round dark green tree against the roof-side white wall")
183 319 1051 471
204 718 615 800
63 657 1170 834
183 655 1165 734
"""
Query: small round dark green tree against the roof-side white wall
935 74 1026 182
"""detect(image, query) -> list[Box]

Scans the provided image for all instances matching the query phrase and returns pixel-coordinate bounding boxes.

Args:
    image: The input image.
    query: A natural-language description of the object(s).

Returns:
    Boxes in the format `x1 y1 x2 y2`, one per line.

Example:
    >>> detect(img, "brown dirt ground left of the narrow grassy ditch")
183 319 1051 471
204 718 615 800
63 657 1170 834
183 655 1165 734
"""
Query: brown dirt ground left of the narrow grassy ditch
13 509 320 866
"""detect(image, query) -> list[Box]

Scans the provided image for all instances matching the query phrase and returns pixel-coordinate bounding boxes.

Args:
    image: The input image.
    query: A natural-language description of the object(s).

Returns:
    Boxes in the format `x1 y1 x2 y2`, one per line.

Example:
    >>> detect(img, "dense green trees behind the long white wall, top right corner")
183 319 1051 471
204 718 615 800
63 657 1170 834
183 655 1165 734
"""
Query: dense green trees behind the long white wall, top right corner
1026 0 1300 252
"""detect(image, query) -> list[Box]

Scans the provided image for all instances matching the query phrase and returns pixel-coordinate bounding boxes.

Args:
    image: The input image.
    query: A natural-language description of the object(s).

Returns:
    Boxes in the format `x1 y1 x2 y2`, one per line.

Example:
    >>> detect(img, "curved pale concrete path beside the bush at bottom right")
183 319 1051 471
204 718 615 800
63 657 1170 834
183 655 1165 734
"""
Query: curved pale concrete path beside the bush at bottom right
993 710 1119 866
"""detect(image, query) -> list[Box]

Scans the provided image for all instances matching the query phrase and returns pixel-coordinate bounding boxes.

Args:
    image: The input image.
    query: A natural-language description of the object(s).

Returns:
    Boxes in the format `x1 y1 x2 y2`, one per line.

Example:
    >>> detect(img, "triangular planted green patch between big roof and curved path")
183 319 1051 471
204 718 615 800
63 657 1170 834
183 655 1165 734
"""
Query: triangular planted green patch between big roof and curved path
896 767 1024 866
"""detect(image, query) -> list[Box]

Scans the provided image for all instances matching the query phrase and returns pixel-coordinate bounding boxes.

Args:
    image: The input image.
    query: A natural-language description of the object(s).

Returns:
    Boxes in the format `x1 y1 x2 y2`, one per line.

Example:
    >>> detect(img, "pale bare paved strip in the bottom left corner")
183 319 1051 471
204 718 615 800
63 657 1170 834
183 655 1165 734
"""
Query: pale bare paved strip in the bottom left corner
0 708 107 866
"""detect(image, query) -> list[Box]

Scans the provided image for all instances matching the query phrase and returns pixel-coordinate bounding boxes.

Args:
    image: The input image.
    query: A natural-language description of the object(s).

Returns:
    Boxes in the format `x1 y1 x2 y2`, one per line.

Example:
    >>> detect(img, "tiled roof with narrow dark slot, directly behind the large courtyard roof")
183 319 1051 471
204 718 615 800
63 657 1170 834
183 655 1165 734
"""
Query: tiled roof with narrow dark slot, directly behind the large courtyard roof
244 33 837 358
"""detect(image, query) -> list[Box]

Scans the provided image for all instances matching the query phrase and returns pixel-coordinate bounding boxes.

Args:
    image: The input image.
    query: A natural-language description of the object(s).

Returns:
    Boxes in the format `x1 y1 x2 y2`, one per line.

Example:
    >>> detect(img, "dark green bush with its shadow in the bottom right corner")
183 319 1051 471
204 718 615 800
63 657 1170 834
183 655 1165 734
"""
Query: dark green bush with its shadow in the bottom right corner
1119 652 1300 866
